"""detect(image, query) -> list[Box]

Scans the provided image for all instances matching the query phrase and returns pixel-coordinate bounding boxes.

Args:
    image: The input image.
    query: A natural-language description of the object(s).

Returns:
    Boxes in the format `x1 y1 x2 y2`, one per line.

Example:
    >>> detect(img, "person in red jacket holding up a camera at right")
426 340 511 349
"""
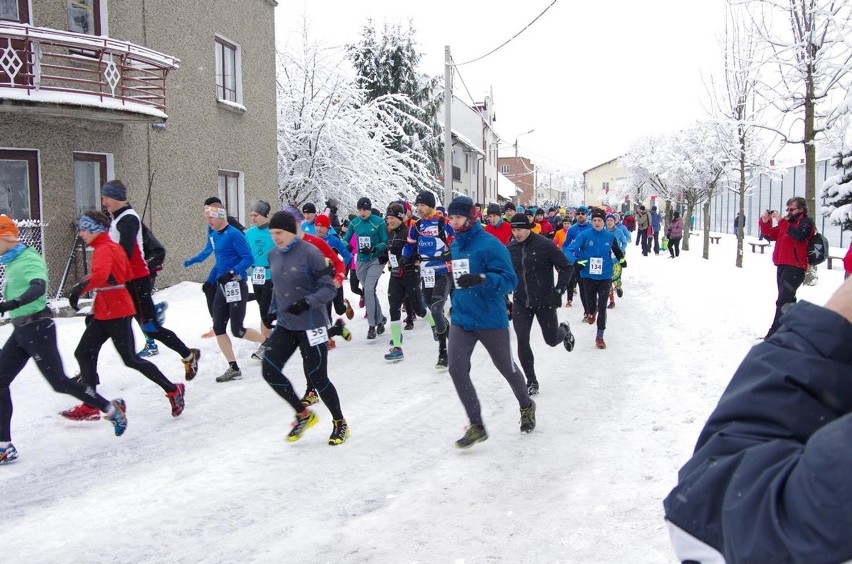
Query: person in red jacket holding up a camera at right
758 196 816 339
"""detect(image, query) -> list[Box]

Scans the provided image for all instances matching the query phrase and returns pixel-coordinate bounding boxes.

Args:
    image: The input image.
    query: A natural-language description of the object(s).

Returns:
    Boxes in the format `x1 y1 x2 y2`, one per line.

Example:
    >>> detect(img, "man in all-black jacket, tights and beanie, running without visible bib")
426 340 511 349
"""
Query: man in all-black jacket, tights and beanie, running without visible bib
509 214 574 396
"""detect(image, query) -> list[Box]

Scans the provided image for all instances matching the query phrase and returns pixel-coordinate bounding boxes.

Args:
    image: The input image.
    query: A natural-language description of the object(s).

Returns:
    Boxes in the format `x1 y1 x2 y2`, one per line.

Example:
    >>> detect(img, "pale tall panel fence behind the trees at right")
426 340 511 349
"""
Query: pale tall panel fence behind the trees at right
695 159 852 247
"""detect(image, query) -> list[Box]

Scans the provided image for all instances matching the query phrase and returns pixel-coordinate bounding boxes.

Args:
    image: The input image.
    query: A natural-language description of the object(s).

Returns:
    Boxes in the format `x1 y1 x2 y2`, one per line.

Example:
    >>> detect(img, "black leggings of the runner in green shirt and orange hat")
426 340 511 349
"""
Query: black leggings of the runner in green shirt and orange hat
0 318 110 442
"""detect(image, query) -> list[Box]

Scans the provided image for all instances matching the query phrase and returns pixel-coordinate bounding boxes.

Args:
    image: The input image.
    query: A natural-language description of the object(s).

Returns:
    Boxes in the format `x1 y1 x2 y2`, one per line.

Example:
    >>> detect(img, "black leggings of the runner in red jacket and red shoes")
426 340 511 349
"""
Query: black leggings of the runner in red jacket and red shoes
74 316 175 392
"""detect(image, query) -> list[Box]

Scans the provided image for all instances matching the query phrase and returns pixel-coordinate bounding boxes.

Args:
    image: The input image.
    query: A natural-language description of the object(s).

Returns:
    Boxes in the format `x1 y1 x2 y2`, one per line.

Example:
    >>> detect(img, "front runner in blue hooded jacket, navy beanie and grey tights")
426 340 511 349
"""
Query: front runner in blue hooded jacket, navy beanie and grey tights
447 196 536 448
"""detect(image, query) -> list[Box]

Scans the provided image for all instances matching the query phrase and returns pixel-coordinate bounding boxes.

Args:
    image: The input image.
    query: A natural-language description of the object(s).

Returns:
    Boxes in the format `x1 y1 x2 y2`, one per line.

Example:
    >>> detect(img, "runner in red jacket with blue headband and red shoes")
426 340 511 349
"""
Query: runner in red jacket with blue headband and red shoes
61 211 184 421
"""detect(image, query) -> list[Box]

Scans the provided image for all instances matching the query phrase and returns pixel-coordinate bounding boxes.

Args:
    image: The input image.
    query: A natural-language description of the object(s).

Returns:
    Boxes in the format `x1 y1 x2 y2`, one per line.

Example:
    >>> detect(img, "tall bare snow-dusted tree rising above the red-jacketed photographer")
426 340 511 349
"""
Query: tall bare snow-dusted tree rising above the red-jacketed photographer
748 0 852 216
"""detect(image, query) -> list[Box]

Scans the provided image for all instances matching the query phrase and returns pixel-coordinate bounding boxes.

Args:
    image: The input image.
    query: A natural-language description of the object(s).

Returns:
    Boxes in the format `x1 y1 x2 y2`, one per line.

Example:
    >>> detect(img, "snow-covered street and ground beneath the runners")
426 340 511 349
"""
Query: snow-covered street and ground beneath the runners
0 235 843 564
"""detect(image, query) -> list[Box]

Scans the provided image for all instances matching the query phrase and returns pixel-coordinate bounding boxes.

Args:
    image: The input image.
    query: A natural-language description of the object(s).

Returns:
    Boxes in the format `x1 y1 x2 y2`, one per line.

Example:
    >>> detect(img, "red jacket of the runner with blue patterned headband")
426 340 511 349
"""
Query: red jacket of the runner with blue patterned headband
81 233 136 321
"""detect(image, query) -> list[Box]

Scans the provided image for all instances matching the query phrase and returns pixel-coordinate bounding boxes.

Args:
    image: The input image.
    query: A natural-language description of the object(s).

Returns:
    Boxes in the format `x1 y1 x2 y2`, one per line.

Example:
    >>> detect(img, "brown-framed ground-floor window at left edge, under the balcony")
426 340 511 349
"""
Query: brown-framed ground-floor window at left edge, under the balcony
0 149 41 219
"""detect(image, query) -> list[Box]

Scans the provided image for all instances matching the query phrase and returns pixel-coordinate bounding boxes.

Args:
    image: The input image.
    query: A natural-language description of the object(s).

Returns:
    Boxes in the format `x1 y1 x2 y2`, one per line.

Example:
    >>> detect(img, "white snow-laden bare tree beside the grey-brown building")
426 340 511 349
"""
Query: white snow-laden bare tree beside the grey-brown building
278 24 436 214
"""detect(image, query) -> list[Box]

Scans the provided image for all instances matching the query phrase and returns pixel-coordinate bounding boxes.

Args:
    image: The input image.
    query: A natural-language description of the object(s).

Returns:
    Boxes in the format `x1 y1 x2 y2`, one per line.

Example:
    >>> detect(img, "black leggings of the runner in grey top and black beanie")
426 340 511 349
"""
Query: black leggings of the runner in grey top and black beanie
263 325 343 419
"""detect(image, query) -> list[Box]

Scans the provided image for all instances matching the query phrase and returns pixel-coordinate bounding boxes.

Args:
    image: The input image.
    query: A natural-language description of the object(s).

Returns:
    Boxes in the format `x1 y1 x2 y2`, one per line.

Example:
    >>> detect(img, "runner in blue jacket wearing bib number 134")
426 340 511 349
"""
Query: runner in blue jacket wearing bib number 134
567 208 627 349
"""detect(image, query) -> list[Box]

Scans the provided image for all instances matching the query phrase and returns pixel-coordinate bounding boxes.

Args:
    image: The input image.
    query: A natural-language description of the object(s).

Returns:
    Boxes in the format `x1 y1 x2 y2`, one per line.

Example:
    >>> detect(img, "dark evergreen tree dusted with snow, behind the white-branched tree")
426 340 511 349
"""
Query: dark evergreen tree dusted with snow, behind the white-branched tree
346 20 443 189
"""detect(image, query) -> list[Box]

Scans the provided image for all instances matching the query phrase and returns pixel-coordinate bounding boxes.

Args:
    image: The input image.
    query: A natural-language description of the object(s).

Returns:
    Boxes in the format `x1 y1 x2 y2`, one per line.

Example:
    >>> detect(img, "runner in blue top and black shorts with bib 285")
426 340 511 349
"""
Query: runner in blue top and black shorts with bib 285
183 203 264 382
